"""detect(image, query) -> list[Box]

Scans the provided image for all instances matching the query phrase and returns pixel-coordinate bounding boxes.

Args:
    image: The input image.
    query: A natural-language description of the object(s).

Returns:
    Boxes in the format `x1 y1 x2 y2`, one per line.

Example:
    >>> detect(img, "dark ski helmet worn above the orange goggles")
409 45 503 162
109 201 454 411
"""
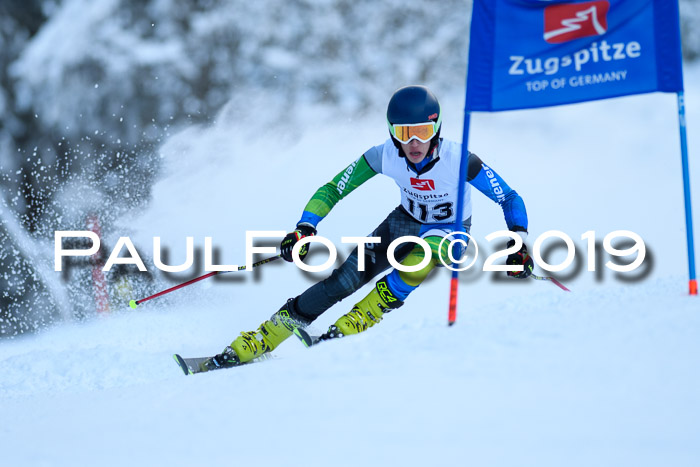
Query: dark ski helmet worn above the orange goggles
386 85 442 151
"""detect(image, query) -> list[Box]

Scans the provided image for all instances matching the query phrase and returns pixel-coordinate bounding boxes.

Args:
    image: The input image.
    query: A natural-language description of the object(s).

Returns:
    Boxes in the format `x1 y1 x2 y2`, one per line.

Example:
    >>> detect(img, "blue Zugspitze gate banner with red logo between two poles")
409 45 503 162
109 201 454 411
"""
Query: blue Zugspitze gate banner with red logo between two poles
466 0 683 111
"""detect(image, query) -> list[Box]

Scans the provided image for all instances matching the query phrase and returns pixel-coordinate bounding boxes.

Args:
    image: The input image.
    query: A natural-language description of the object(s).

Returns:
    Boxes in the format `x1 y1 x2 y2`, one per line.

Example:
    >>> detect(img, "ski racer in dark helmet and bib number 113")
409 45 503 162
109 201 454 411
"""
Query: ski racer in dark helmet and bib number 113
206 86 533 369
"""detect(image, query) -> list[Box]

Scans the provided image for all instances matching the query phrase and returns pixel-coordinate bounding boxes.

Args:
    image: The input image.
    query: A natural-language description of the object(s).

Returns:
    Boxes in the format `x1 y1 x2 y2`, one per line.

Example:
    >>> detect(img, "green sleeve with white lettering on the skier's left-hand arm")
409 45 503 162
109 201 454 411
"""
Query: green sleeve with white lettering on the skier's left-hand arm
304 155 377 217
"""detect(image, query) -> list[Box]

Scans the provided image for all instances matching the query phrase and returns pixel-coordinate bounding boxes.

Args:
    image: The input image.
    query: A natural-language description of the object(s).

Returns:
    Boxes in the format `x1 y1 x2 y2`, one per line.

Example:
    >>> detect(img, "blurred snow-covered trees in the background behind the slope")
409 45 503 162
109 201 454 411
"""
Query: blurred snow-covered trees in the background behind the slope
0 0 700 334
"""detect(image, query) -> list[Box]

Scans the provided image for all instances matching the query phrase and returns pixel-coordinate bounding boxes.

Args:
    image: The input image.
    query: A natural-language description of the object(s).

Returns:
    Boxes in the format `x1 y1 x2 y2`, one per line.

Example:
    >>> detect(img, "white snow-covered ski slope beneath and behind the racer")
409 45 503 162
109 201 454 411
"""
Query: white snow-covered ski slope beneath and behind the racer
0 69 700 466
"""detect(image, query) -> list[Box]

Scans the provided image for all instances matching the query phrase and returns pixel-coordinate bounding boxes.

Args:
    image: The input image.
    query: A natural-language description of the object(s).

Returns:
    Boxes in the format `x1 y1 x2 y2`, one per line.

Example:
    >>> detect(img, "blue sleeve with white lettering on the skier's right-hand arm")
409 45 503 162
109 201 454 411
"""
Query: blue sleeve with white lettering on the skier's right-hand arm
468 154 527 232
